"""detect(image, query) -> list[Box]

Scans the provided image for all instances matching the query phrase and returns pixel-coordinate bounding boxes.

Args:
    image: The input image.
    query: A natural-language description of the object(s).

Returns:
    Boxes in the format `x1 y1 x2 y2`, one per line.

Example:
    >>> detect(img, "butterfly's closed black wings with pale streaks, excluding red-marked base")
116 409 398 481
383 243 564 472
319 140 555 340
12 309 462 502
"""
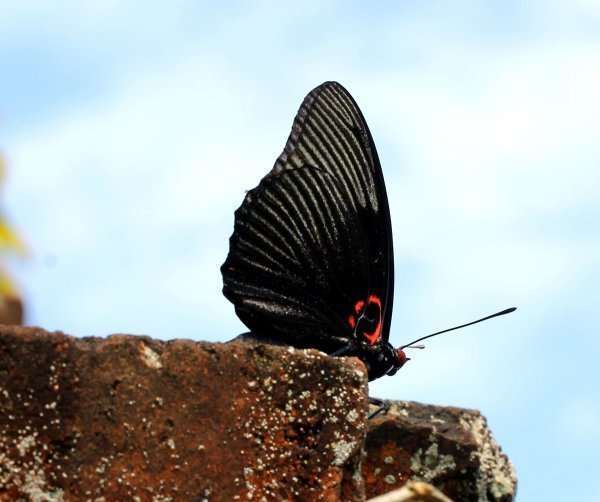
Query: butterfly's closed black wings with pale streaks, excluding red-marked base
221 82 393 351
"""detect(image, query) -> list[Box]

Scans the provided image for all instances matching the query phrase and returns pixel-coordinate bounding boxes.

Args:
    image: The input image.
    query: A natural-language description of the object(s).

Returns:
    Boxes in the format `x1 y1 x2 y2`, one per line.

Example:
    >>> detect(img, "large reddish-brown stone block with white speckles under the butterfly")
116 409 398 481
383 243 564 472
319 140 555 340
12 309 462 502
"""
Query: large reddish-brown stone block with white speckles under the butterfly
0 326 368 502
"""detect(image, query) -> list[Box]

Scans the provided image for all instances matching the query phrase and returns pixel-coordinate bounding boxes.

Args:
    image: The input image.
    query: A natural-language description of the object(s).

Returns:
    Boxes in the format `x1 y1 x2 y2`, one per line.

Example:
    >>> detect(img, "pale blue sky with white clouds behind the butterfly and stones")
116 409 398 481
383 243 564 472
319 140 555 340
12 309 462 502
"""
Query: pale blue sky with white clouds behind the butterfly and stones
0 0 600 501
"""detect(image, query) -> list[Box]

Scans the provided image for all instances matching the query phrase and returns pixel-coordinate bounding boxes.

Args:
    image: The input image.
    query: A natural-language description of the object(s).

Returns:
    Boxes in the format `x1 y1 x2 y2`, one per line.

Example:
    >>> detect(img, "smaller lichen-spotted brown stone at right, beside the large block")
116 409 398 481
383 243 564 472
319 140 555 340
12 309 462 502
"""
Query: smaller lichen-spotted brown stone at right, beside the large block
362 401 517 502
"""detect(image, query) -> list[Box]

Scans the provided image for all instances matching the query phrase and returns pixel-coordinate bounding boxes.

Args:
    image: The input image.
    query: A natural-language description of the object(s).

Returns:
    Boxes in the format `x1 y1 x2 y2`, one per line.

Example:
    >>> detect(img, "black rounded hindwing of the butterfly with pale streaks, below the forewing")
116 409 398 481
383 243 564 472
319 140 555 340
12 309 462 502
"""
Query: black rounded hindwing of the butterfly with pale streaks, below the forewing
222 166 368 349
